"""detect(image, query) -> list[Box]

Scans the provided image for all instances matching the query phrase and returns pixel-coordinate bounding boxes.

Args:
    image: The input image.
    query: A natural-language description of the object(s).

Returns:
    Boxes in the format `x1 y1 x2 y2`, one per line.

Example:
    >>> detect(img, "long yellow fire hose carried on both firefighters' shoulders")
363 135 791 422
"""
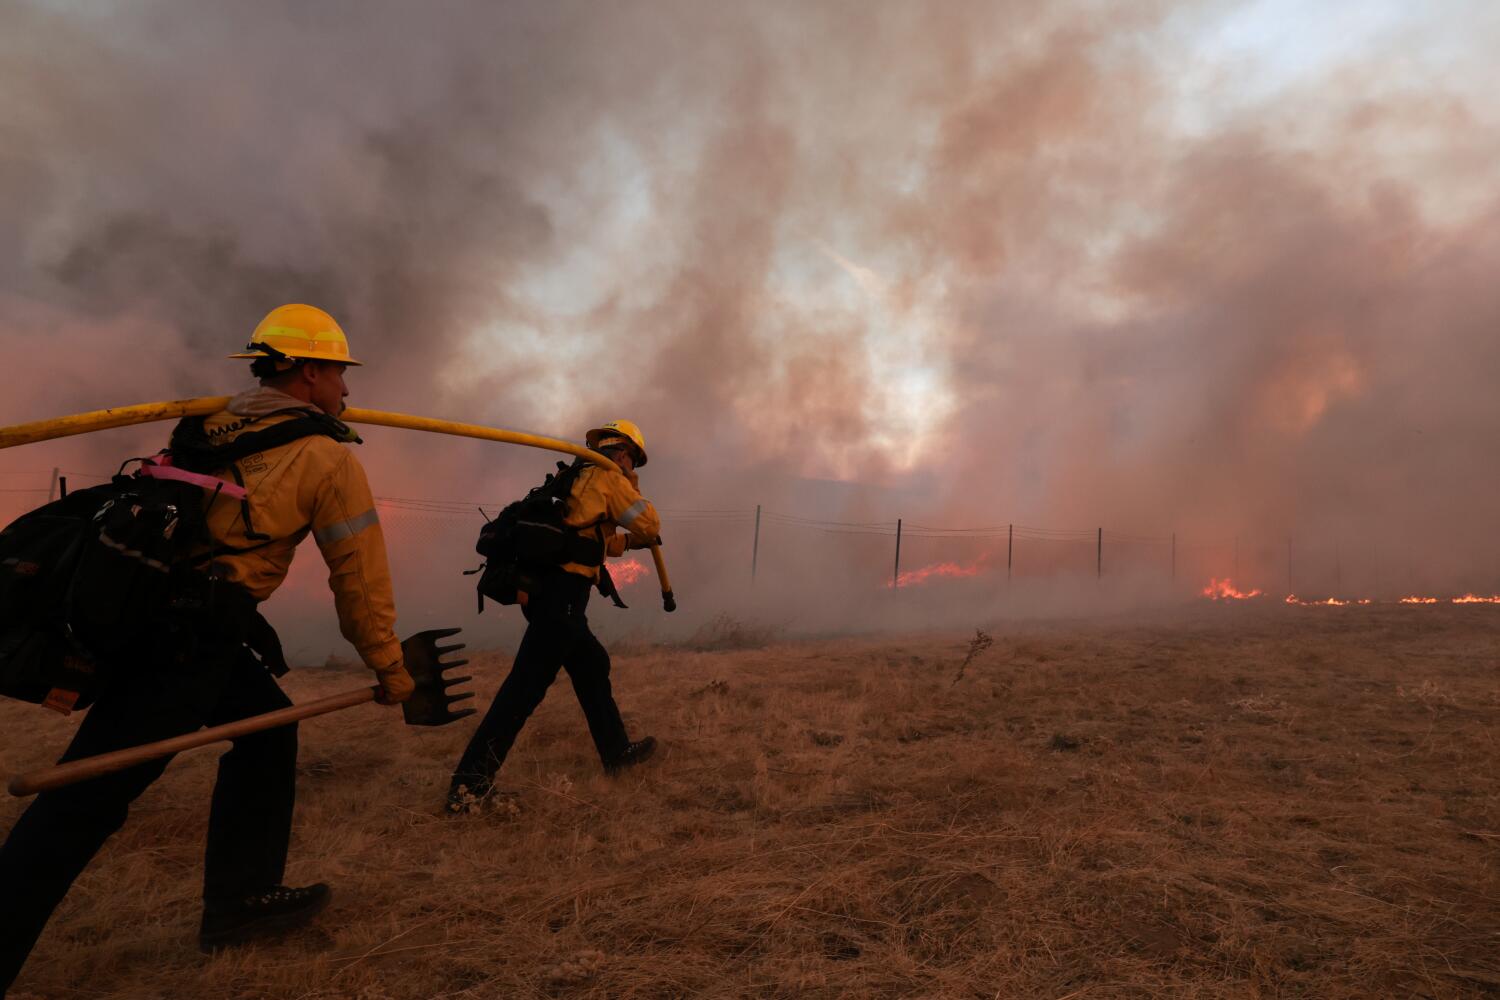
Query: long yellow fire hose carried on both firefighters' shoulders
0 396 677 612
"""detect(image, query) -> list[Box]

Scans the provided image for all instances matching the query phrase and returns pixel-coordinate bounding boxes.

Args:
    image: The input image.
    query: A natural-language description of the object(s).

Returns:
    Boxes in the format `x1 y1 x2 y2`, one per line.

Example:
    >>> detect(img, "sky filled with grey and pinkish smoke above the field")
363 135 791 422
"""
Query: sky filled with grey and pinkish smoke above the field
0 0 1500 626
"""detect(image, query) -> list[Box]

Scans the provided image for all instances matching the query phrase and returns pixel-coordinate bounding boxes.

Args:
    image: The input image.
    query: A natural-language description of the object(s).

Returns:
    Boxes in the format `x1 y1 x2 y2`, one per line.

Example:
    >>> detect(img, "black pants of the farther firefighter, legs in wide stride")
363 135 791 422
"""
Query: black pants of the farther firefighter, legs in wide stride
453 571 630 793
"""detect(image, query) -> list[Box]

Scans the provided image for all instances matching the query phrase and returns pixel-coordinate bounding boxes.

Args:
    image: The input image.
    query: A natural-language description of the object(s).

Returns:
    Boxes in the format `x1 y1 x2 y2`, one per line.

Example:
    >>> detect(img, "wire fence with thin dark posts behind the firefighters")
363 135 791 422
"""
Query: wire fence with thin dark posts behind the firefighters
0 469 1500 595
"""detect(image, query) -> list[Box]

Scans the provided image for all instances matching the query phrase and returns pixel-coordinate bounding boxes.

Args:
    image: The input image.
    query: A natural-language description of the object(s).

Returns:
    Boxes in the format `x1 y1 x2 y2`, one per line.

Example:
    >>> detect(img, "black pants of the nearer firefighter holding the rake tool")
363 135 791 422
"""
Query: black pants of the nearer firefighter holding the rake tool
0 611 297 996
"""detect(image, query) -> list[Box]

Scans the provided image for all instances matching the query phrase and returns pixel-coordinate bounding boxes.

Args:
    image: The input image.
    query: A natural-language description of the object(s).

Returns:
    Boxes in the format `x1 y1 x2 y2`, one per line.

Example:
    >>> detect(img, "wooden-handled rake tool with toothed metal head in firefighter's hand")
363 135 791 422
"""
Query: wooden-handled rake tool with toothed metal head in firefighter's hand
11 628 474 796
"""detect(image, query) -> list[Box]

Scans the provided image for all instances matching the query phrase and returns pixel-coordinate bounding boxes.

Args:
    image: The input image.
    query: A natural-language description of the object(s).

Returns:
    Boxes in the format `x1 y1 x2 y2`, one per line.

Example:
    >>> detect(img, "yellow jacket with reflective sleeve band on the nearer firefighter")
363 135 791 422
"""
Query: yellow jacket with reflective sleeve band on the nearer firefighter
204 388 401 670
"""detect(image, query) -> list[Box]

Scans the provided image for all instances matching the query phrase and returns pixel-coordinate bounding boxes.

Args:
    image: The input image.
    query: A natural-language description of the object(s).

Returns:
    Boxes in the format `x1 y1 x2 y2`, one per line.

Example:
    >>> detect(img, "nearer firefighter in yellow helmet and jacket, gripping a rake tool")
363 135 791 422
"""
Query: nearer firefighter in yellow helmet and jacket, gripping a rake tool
0 304 413 996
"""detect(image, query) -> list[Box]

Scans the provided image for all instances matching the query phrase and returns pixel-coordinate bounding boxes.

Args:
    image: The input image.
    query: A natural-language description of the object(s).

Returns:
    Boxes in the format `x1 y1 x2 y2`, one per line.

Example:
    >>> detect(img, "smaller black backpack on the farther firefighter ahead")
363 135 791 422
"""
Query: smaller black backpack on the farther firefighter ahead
468 459 624 612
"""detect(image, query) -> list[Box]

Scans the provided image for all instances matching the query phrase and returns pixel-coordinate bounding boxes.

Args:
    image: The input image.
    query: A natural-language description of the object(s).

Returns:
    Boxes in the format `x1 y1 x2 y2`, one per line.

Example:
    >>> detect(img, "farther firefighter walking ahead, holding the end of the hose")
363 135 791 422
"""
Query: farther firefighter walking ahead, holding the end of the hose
449 420 662 813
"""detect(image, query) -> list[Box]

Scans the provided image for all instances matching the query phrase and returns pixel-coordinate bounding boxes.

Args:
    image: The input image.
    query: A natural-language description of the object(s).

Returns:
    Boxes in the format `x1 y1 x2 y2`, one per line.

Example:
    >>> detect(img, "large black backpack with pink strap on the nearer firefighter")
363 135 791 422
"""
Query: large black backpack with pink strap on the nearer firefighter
0 414 353 712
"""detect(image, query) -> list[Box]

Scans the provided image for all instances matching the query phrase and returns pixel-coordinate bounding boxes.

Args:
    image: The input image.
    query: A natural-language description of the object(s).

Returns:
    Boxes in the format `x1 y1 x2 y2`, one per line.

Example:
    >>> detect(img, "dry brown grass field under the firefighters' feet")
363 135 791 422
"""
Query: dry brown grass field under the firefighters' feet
0 606 1500 1000
